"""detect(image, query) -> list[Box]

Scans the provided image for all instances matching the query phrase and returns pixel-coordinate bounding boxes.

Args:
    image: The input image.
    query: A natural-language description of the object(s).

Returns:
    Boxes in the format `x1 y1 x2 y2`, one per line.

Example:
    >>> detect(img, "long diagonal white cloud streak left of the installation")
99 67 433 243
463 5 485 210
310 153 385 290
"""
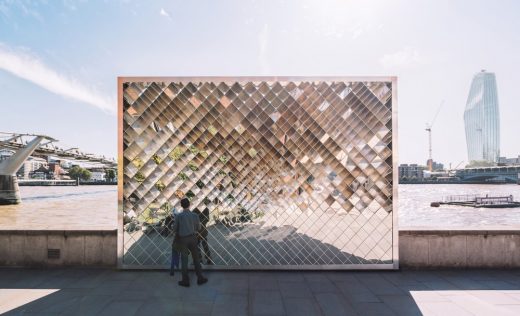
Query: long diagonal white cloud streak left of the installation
0 43 116 114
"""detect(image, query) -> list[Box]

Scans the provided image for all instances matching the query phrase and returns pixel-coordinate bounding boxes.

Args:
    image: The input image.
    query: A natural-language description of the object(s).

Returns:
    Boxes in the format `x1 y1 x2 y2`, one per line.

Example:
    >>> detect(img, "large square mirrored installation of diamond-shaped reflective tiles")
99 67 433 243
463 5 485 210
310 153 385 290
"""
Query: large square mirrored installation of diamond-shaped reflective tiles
119 77 397 269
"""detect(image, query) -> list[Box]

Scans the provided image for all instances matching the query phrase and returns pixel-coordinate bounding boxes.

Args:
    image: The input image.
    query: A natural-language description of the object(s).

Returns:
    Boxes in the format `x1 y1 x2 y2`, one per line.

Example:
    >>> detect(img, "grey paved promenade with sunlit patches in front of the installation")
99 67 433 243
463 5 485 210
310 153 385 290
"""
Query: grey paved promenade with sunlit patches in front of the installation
0 269 520 316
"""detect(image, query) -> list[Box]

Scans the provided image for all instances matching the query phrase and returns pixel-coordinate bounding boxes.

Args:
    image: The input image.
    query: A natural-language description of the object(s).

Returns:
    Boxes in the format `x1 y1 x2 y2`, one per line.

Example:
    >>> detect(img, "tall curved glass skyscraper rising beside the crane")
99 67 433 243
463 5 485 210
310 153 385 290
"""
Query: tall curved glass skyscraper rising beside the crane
464 70 500 162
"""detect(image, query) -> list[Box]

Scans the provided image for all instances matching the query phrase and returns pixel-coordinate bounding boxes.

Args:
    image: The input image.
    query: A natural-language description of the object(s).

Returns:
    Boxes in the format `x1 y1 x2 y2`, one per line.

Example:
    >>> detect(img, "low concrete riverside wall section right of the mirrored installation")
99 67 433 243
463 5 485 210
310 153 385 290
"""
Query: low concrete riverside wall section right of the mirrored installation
399 228 520 269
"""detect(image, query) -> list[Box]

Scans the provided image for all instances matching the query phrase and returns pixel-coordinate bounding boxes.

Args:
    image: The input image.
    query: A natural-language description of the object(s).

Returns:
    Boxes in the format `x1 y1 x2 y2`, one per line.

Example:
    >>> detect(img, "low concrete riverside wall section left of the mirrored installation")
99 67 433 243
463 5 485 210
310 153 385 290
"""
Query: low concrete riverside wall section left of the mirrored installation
0 229 117 267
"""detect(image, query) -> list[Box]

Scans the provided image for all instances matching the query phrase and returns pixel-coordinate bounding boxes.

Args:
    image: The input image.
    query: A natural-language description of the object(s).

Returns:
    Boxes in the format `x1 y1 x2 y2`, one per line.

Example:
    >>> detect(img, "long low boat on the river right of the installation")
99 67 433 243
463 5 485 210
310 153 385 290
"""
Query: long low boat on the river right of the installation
430 194 520 208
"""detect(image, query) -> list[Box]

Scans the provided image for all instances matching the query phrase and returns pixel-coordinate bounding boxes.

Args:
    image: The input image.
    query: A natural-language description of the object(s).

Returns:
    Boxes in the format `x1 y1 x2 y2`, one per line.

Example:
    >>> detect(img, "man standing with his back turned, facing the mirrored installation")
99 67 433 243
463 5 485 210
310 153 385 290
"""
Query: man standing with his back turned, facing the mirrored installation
173 198 208 287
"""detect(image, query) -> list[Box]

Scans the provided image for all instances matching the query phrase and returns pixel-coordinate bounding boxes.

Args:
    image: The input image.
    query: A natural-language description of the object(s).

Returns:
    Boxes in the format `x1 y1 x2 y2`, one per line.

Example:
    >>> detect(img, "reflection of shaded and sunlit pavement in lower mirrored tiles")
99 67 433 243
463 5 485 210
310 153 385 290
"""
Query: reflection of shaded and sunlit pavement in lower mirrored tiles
124 213 392 266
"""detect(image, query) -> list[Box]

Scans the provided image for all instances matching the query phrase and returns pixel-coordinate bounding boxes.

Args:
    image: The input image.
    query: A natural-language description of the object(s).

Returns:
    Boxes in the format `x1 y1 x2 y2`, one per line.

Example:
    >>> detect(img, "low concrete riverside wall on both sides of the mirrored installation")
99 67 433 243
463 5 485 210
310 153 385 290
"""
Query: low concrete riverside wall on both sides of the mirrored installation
0 228 520 269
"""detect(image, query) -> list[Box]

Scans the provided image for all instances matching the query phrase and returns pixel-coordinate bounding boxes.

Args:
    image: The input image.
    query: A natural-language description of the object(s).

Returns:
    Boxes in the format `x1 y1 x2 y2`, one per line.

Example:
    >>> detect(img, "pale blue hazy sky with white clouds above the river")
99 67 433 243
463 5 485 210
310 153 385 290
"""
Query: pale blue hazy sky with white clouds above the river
0 0 520 167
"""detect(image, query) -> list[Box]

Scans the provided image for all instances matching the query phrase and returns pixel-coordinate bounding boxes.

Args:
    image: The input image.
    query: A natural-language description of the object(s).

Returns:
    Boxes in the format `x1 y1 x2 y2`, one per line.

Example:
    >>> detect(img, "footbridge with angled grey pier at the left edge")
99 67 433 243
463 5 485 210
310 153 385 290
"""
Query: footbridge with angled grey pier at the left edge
0 132 117 205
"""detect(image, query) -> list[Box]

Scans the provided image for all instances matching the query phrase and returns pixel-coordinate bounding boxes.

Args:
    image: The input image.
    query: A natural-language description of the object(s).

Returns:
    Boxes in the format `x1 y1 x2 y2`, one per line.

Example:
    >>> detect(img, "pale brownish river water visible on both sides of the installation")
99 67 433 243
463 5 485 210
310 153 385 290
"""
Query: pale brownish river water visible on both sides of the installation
0 184 520 230
